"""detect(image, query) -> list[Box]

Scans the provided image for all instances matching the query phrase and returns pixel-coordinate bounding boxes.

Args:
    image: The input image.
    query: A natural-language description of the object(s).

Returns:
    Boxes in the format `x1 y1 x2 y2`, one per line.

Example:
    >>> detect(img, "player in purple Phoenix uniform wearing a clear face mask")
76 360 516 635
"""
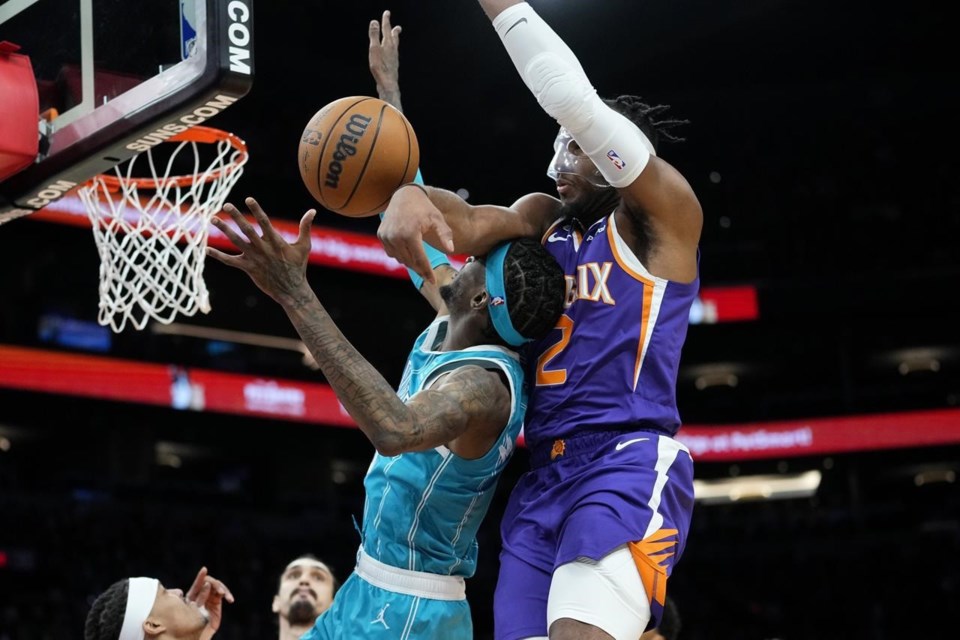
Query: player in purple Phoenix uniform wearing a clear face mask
379 0 703 640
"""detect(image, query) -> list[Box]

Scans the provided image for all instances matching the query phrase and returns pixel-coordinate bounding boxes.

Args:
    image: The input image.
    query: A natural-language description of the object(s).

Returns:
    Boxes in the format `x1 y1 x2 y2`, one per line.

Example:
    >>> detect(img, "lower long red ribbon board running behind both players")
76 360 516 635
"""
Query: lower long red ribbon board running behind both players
0 345 960 462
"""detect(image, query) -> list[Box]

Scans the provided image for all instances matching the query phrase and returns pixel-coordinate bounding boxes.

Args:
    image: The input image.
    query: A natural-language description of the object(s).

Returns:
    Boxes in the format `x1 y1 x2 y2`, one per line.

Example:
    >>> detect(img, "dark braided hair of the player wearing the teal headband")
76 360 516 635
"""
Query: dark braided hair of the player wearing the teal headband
489 238 566 341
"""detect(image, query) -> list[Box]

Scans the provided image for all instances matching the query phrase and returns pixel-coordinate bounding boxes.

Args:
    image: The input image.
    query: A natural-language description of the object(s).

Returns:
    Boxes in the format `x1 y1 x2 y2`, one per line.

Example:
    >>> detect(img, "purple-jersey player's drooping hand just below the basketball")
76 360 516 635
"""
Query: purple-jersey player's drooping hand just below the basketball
377 187 454 284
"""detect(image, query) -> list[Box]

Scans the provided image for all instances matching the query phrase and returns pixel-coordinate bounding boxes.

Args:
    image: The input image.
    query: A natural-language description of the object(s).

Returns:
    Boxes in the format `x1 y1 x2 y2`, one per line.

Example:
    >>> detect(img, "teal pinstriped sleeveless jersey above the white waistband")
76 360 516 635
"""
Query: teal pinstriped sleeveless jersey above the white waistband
362 317 527 578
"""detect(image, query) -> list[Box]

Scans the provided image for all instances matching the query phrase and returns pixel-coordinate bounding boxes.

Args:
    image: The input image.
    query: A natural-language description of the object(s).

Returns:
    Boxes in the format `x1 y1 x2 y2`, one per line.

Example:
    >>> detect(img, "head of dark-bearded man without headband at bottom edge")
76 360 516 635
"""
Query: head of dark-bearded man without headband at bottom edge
273 554 339 640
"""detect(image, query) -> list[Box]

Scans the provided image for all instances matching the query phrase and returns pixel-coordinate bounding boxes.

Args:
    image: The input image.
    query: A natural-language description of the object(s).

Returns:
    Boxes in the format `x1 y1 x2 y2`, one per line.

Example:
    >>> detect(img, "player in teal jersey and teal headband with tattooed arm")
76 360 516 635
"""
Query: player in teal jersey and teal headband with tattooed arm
208 187 564 640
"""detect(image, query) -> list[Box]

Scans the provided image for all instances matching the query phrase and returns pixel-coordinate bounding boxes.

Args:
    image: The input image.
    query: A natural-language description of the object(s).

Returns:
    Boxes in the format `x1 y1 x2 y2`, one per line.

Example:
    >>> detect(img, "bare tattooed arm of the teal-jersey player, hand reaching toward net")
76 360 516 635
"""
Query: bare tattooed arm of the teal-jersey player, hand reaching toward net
207 198 510 458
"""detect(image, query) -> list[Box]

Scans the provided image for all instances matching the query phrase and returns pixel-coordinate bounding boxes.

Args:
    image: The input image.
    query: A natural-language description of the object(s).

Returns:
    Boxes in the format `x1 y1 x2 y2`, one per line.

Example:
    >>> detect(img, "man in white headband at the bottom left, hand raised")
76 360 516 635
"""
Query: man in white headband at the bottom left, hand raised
83 567 233 640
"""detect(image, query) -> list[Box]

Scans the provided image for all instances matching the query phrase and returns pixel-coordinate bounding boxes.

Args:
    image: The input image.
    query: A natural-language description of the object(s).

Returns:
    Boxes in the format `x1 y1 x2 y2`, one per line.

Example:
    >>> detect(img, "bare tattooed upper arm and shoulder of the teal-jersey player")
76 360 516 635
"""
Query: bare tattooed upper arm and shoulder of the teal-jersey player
405 365 511 458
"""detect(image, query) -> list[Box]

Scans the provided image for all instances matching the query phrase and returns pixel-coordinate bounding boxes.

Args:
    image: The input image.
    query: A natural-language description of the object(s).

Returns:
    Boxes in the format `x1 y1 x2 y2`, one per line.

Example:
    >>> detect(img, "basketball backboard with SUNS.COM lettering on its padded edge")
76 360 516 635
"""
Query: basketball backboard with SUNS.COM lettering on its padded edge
0 0 253 224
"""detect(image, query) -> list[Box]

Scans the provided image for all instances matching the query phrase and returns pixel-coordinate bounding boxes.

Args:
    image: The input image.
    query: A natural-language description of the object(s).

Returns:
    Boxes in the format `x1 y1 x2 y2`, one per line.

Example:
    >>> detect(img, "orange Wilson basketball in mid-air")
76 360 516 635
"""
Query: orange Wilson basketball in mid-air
297 96 420 218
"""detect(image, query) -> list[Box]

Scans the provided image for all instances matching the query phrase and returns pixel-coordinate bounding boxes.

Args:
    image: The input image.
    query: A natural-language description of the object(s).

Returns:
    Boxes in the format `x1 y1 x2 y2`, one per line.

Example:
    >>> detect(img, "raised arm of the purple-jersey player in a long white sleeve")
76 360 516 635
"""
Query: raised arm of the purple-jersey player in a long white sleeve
479 0 703 281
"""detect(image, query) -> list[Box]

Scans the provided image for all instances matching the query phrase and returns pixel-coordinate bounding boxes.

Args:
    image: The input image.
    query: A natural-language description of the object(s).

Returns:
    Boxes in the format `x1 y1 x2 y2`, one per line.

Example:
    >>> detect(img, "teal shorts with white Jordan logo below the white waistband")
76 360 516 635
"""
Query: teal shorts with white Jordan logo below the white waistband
300 573 473 640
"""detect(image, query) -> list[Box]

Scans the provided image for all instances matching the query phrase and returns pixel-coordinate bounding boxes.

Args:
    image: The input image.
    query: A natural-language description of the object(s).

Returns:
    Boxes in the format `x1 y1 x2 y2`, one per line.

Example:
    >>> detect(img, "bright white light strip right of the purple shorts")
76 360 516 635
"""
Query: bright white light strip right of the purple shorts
693 470 822 505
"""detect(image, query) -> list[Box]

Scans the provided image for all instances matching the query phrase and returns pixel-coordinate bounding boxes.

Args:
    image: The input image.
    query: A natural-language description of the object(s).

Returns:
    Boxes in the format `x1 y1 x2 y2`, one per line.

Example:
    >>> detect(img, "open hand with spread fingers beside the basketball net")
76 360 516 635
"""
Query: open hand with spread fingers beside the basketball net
207 198 317 304
